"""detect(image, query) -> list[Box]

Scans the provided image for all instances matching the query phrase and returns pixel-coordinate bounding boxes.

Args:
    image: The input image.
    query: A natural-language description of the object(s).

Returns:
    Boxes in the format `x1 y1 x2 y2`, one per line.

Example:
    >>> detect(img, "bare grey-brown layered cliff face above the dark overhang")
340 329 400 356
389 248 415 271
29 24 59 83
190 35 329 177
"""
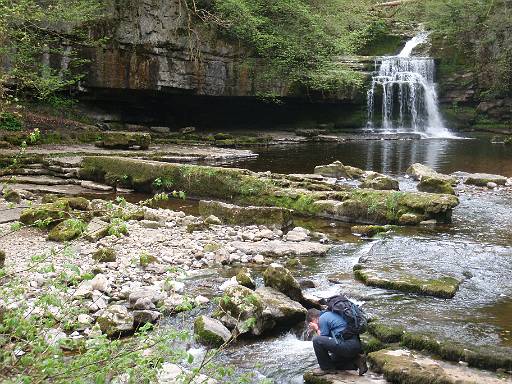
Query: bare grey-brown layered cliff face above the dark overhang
84 0 292 96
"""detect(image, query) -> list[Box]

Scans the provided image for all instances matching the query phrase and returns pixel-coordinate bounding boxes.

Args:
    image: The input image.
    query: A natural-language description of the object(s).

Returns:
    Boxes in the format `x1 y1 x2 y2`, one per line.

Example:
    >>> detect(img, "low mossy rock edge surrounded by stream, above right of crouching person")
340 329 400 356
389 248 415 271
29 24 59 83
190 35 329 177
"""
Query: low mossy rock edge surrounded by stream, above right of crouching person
354 265 460 299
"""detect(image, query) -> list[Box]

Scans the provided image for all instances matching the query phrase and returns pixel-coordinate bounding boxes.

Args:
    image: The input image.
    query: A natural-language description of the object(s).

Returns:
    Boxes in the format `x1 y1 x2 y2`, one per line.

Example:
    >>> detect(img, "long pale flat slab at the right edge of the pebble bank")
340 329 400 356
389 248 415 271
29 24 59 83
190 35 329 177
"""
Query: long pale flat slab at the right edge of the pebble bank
231 240 331 257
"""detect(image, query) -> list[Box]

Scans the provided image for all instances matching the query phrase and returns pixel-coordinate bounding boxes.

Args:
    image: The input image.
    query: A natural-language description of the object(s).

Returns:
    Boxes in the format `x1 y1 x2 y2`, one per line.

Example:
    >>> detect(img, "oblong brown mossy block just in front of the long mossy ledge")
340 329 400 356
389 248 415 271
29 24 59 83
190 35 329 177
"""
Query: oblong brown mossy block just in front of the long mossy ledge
199 200 293 229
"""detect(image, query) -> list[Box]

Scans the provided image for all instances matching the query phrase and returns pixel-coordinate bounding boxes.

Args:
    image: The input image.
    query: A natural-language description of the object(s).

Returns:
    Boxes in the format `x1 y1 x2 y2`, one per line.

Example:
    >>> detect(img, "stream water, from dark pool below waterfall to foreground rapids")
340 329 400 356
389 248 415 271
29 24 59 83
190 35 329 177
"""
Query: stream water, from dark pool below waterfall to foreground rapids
158 137 512 384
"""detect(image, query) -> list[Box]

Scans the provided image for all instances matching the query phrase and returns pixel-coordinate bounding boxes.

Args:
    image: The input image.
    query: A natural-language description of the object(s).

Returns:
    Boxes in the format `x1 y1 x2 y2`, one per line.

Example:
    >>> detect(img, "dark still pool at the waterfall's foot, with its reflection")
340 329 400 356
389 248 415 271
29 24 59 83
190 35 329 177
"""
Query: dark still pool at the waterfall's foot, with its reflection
236 138 512 176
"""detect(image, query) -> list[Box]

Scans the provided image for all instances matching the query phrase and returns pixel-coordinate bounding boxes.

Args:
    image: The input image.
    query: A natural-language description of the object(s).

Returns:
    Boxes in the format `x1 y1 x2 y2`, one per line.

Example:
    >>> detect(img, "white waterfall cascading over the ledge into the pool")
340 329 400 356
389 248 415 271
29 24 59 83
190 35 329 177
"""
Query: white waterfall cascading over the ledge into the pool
367 32 452 137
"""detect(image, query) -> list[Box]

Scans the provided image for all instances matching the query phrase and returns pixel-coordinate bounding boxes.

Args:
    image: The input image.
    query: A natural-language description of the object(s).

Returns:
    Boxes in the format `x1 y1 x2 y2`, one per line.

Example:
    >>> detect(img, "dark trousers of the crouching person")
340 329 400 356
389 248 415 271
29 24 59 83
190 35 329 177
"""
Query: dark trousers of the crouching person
313 336 362 371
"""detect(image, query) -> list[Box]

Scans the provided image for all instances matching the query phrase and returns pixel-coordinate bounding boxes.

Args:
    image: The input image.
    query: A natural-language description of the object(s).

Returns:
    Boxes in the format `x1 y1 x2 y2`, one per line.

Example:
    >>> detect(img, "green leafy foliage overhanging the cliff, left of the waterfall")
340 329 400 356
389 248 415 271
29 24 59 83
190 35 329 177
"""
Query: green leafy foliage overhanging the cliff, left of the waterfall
189 0 373 91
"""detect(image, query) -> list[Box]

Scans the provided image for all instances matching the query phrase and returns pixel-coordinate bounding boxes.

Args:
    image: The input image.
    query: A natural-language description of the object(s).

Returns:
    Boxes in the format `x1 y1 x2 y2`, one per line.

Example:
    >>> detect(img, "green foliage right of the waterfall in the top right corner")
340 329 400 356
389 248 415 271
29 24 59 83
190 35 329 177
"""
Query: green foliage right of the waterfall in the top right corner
399 0 512 98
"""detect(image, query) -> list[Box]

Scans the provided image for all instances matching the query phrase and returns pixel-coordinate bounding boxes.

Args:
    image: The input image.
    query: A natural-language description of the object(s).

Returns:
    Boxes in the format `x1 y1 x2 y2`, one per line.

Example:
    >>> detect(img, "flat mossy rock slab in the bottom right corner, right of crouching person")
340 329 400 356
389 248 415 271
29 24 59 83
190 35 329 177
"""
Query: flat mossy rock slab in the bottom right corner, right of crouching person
368 349 512 384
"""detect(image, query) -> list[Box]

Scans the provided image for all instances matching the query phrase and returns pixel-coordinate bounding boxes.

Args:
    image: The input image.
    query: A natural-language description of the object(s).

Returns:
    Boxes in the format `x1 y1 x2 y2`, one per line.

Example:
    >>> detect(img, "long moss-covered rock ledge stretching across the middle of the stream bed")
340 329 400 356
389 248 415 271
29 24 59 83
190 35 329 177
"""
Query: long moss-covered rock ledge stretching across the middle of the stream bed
81 156 459 224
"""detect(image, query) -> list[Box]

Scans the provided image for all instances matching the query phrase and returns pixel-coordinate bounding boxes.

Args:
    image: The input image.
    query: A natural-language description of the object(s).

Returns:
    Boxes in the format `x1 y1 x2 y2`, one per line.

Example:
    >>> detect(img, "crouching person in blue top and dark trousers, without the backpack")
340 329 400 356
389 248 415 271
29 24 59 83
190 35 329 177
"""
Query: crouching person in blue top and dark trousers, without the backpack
306 309 368 376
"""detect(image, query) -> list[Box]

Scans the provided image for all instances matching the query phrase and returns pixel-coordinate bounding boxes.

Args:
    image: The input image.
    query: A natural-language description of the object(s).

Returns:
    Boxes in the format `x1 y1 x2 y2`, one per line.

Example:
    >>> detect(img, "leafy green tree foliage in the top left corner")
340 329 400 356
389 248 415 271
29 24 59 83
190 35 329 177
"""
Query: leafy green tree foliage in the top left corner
0 0 103 100
